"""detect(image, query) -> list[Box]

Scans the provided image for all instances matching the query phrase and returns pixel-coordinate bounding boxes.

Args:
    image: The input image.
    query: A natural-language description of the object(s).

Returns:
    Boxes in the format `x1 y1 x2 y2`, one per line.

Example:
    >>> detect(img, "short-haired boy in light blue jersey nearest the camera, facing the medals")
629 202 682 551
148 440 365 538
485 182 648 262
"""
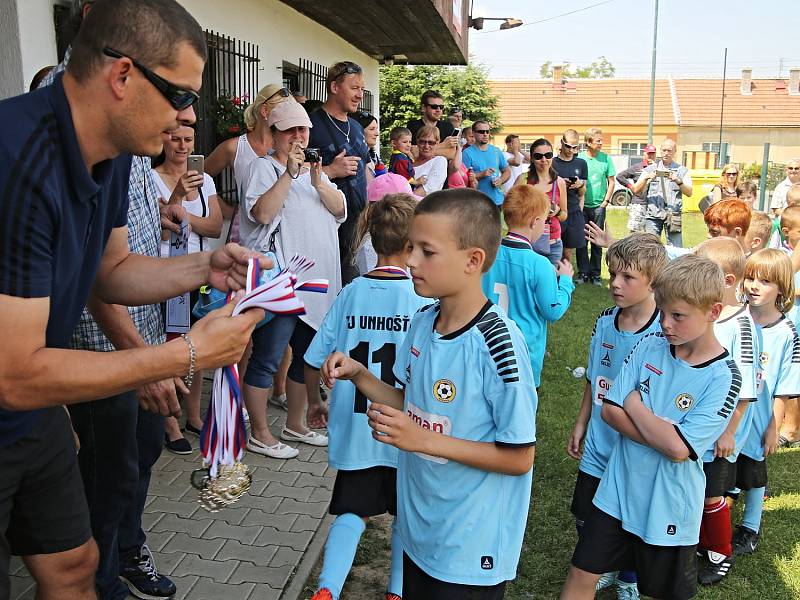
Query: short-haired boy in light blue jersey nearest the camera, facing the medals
322 189 537 600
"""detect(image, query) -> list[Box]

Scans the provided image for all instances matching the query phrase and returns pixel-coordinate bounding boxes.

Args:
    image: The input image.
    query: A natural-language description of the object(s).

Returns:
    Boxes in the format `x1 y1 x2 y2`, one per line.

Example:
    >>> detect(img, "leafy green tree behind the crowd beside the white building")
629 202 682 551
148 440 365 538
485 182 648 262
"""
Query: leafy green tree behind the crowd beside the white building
380 64 501 145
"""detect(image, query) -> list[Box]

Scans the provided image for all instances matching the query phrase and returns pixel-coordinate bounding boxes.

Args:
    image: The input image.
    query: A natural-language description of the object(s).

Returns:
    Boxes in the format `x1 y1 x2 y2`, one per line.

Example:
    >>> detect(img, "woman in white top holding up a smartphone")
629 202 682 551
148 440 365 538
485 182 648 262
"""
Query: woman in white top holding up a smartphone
153 125 222 454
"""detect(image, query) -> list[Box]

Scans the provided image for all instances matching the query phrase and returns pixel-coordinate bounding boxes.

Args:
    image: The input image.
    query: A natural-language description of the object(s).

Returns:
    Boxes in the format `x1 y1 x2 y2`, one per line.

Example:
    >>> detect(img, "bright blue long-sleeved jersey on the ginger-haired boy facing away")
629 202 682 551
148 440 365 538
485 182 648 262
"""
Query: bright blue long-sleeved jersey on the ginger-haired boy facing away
482 236 575 387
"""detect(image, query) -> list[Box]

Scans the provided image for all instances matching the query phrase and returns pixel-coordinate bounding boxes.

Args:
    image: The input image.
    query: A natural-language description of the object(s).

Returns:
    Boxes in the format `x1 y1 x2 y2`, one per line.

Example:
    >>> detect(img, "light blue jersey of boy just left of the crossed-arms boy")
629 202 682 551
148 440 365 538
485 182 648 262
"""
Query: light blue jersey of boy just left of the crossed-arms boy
580 307 661 479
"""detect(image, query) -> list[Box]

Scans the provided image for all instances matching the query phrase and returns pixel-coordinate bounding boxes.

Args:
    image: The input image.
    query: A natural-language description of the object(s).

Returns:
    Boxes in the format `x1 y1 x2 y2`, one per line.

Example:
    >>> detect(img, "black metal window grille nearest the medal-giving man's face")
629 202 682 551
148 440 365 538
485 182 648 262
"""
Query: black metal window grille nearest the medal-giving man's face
195 29 259 204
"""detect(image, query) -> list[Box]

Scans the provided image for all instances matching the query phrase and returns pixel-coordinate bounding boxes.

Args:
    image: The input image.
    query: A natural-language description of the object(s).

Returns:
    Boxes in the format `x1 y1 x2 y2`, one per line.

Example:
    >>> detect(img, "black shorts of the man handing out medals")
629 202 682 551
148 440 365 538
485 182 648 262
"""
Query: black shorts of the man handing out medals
0 406 92 564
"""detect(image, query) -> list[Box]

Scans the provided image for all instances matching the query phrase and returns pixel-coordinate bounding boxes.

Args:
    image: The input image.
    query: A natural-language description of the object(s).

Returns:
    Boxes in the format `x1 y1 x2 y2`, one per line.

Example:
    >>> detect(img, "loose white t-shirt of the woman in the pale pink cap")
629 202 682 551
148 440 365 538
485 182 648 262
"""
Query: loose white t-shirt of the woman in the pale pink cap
239 156 347 330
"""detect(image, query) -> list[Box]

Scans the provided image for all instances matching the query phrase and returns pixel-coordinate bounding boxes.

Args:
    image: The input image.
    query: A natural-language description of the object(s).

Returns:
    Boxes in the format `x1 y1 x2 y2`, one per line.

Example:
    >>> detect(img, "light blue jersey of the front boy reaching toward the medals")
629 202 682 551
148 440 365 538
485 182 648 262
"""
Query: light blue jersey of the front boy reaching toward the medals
395 302 537 585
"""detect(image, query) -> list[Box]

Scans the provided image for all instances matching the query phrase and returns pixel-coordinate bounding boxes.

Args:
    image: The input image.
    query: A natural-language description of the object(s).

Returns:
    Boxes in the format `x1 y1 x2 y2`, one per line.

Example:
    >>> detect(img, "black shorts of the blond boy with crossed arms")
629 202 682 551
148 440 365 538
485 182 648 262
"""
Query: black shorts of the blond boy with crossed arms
572 506 697 600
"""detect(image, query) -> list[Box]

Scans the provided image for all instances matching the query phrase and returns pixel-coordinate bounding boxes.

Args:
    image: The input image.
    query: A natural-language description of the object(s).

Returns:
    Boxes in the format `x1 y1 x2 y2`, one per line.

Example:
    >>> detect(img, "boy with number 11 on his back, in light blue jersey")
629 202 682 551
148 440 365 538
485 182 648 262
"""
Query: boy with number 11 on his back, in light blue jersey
304 194 426 600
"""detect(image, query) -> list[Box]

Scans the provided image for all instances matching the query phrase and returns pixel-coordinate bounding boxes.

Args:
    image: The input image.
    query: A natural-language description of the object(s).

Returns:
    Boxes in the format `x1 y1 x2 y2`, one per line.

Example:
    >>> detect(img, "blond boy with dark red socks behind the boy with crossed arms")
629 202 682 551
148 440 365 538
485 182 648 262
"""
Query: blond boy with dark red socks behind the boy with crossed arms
695 237 758 585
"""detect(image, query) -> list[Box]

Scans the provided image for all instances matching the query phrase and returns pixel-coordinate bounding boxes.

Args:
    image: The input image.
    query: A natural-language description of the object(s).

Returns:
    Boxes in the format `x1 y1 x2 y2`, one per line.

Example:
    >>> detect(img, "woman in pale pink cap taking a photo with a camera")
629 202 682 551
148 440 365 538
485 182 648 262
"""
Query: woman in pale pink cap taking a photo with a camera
239 100 347 458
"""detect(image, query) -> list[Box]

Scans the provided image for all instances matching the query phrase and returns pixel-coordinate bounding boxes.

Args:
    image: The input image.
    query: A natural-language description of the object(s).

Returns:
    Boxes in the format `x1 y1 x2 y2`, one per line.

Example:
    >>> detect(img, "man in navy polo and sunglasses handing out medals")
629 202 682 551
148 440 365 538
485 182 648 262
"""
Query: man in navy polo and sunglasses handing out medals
0 0 269 600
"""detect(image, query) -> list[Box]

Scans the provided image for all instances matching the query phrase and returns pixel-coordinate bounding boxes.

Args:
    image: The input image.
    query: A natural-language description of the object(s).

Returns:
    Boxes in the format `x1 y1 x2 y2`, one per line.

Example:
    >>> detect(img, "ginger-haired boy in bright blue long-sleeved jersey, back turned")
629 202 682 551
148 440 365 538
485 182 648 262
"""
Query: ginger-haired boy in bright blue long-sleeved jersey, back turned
482 185 575 389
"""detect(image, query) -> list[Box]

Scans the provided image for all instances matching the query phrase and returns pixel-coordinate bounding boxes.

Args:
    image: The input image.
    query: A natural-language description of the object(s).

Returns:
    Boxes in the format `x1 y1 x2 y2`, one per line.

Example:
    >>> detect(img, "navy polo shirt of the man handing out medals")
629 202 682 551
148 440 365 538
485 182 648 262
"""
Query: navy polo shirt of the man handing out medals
0 75 131 448
